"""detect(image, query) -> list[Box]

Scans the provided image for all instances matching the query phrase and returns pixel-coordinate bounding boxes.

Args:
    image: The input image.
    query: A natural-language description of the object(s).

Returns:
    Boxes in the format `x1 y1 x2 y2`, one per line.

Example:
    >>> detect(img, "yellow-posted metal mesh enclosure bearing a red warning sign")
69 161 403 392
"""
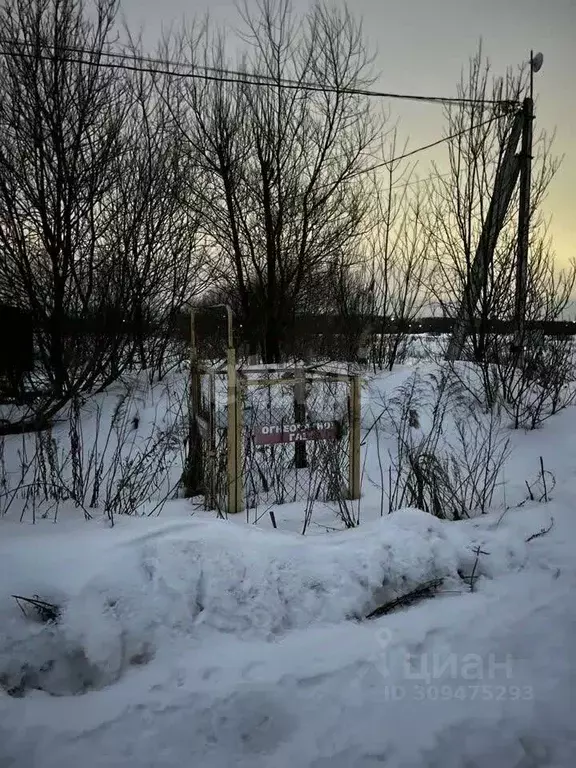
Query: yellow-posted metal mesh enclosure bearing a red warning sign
188 348 360 514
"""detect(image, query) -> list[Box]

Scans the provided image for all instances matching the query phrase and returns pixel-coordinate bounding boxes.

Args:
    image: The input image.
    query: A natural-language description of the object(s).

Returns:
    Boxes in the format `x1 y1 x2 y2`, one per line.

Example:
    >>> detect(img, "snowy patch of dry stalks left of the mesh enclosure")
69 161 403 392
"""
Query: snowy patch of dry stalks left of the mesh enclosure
0 375 187 522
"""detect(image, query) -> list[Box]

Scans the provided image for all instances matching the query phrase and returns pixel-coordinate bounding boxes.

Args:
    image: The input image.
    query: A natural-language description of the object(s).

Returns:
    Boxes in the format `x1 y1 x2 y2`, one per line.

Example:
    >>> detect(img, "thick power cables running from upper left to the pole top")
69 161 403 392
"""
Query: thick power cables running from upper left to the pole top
0 40 518 106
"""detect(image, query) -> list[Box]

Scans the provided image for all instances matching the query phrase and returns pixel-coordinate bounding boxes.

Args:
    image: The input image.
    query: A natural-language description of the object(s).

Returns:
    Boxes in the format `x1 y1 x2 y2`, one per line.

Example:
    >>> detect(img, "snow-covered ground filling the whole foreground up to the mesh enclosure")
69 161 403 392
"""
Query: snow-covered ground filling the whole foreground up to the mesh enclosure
0 369 576 768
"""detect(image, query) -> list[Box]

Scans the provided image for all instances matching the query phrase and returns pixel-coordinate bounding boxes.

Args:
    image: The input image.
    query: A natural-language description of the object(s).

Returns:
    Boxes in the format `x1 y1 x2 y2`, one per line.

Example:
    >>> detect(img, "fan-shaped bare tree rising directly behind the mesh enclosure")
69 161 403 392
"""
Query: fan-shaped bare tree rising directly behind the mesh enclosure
158 0 378 361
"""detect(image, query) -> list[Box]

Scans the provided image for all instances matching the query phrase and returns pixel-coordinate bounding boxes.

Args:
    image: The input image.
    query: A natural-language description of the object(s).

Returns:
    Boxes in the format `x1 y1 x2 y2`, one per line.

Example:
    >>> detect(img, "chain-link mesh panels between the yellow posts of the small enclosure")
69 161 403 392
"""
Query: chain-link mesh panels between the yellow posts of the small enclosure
198 370 350 514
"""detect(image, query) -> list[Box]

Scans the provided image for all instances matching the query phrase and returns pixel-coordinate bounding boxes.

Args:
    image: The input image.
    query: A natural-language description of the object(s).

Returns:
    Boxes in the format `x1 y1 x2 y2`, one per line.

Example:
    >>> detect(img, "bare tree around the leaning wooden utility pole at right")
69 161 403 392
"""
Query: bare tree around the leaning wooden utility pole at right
429 51 576 428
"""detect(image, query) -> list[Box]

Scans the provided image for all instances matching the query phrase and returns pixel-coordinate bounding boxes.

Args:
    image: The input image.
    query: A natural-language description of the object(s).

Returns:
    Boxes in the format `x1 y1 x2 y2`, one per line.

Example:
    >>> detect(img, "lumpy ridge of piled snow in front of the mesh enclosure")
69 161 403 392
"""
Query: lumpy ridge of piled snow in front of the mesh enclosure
0 510 522 695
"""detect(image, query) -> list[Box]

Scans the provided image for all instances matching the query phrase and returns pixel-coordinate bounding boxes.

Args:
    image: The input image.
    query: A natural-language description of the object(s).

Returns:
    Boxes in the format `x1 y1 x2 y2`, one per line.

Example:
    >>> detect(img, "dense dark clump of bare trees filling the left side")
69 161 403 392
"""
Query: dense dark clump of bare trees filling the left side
0 0 213 428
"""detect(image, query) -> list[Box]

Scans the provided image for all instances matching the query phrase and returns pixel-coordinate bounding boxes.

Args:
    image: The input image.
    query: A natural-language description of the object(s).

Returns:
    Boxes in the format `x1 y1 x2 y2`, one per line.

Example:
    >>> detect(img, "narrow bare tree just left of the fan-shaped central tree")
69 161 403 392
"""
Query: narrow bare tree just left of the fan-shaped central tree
104 44 209 374
